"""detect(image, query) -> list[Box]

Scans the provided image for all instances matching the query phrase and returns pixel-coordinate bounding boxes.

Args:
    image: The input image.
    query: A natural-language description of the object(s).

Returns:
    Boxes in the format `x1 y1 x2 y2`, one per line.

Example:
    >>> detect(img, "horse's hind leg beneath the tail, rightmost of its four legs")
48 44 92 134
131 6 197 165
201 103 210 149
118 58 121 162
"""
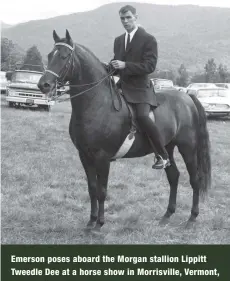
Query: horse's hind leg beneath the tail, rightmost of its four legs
178 144 199 223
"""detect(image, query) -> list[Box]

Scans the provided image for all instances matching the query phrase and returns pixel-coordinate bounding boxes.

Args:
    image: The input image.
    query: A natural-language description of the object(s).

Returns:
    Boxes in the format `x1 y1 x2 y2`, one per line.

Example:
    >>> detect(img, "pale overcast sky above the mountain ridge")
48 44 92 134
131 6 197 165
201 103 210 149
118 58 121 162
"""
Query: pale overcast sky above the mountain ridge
0 0 230 24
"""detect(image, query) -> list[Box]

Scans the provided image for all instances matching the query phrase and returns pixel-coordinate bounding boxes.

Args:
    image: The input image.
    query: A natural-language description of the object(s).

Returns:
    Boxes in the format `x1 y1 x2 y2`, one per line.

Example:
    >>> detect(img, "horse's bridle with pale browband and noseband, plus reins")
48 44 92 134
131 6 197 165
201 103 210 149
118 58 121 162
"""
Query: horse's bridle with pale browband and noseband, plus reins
45 42 122 111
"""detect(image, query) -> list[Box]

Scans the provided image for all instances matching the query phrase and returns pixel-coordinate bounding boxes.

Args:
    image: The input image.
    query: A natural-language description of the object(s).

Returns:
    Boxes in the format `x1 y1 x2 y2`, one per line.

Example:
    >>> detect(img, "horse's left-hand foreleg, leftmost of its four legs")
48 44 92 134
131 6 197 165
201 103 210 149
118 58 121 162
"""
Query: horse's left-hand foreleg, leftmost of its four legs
79 152 98 228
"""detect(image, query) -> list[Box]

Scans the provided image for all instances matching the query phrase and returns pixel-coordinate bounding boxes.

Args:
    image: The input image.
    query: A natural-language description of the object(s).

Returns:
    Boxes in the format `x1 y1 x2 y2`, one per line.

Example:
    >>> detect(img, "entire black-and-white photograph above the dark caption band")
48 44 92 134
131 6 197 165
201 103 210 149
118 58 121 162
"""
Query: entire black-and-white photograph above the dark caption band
0 0 230 245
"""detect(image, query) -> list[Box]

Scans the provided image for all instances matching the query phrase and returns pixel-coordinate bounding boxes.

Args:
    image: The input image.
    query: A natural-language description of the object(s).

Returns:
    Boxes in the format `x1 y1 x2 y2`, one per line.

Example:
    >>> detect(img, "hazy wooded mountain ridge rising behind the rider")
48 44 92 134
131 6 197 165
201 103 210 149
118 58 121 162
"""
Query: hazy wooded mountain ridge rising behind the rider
2 3 230 71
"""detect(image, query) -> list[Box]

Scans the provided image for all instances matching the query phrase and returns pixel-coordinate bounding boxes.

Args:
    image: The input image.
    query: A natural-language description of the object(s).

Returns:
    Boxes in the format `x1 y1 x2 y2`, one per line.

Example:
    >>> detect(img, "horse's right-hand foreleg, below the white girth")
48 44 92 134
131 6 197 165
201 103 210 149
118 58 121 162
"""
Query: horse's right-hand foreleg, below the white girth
95 151 110 230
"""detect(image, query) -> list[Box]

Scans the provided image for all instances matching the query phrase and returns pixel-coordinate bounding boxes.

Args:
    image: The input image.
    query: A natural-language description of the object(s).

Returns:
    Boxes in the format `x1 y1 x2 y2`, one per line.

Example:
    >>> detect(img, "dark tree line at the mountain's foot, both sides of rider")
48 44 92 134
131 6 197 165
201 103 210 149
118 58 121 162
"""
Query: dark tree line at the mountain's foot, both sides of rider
1 38 230 87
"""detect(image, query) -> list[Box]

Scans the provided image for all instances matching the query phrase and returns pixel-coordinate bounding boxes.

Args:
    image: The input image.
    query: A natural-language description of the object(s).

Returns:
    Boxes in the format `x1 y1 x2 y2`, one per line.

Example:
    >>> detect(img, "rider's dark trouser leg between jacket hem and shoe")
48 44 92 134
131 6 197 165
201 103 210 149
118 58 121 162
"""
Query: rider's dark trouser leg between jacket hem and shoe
133 103 168 159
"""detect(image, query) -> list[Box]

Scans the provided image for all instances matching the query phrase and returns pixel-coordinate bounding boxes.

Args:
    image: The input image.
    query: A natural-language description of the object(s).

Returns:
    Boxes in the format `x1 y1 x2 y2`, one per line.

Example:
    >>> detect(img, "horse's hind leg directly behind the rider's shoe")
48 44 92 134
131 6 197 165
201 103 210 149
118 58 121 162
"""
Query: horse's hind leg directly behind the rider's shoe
160 143 180 224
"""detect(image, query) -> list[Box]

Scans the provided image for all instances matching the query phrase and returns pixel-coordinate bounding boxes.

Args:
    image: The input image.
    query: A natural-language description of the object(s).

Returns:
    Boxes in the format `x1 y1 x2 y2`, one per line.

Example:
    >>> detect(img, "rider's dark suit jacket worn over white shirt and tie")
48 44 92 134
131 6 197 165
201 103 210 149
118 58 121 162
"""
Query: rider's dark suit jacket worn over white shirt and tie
114 27 158 106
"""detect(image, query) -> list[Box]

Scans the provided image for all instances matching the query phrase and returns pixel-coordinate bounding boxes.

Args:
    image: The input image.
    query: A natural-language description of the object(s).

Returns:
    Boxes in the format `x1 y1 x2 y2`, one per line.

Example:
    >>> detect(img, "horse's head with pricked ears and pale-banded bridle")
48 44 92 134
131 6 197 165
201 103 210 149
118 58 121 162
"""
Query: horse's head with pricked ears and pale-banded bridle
38 30 74 95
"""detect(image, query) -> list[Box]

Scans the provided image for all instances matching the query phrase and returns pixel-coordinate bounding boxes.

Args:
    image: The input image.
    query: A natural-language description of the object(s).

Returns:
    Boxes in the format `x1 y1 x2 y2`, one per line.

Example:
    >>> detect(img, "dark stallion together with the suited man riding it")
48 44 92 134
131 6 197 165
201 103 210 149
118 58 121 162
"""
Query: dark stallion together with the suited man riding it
38 24 211 230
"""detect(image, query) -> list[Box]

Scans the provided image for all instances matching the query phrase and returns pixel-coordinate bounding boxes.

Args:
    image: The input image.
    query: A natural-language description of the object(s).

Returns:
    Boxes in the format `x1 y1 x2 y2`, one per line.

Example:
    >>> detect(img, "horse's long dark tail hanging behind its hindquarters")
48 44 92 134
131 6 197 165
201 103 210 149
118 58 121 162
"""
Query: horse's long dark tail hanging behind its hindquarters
190 95 211 196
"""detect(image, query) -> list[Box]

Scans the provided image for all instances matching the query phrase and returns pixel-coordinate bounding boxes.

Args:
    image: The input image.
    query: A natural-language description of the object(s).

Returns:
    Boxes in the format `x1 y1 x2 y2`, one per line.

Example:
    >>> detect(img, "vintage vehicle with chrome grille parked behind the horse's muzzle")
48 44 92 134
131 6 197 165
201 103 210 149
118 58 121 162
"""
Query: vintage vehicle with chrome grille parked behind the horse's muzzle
6 70 50 110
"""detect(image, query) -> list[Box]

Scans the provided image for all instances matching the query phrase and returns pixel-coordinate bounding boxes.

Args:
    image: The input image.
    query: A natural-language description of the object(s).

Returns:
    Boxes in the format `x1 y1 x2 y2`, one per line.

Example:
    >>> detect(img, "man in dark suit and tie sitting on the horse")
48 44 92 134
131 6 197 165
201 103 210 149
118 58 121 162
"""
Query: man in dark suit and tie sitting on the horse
107 5 170 169
